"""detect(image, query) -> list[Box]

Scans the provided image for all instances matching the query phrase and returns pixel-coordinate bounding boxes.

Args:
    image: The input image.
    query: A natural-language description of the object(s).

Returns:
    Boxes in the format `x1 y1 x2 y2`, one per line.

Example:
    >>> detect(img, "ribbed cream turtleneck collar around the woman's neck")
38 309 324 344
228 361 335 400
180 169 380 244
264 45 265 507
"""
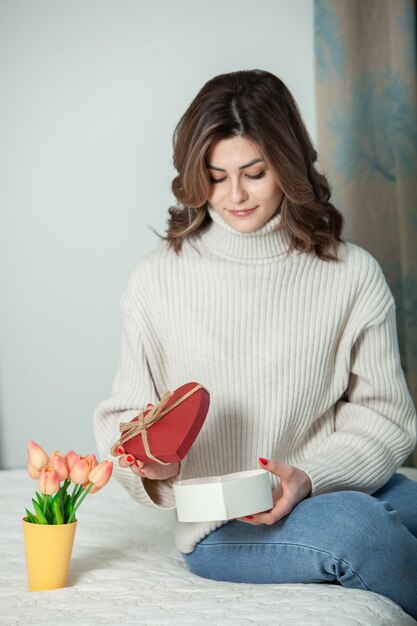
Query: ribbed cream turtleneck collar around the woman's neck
194 204 290 263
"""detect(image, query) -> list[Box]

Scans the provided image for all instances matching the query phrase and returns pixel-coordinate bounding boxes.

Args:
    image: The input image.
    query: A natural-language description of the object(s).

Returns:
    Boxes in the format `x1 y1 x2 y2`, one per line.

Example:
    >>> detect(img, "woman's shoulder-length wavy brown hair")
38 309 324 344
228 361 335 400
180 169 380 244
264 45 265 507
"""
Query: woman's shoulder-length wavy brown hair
156 69 344 260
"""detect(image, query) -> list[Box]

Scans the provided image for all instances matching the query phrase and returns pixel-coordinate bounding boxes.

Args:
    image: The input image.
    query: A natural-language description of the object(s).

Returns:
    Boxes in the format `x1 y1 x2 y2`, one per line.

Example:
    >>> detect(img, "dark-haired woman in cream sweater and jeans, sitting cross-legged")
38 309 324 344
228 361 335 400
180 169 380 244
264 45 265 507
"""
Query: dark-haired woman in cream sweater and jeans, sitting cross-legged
95 70 417 617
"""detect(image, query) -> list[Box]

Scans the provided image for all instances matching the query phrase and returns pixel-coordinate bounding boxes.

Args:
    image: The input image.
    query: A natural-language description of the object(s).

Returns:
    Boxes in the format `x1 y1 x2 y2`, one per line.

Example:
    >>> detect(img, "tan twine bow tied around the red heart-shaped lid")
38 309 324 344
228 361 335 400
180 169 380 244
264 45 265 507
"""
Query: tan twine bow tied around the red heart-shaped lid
110 384 204 465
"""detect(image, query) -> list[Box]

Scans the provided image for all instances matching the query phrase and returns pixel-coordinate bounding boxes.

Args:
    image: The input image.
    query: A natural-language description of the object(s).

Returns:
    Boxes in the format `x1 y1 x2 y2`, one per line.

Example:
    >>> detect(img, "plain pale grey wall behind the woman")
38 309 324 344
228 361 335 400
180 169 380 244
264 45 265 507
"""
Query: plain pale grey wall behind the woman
0 0 316 467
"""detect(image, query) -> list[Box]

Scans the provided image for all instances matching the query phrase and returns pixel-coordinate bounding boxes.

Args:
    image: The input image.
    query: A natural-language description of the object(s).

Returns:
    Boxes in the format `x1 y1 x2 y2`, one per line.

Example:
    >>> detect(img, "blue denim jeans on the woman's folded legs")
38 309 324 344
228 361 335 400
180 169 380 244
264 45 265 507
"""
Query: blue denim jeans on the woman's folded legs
183 474 417 619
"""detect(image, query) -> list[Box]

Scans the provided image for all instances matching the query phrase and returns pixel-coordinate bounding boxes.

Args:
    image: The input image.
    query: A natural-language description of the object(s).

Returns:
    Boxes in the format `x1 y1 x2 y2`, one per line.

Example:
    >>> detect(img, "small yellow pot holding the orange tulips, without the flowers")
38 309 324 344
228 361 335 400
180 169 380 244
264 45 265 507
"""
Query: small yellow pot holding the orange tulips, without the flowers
22 518 77 591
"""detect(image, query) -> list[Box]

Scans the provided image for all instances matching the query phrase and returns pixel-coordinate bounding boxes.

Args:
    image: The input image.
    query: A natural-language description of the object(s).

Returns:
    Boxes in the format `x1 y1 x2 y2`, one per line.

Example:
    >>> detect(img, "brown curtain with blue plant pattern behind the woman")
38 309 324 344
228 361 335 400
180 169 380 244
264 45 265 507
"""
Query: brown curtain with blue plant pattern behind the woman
314 0 417 467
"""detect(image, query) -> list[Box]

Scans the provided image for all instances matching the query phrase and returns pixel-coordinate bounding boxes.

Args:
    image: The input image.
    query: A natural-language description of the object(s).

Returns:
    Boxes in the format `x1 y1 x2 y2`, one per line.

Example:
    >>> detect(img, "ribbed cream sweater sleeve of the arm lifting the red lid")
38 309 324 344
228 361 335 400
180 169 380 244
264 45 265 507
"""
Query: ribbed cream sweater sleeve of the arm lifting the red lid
94 298 178 509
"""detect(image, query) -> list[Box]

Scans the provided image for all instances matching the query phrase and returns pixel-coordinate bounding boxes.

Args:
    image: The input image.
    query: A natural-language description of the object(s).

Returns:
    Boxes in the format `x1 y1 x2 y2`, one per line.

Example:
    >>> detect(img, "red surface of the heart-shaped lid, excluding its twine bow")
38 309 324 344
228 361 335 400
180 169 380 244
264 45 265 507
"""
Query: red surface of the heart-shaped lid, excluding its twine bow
123 383 210 463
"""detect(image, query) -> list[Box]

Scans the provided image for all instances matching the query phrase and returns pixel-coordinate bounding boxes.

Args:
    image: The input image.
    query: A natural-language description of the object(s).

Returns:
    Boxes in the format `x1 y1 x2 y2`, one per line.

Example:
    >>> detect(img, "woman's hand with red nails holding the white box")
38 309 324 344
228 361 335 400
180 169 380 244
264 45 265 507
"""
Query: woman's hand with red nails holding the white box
236 459 312 525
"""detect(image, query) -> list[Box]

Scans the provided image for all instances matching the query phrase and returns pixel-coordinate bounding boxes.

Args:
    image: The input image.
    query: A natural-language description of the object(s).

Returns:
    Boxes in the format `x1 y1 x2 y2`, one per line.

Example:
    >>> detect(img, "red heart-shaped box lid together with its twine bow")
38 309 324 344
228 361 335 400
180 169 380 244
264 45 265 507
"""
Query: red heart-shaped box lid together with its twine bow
112 382 210 463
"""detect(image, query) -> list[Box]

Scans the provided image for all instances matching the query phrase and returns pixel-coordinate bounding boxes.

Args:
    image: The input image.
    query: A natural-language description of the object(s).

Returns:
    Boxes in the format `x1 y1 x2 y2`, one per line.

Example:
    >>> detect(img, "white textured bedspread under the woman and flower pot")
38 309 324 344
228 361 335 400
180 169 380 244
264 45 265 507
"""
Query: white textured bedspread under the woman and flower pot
0 470 417 626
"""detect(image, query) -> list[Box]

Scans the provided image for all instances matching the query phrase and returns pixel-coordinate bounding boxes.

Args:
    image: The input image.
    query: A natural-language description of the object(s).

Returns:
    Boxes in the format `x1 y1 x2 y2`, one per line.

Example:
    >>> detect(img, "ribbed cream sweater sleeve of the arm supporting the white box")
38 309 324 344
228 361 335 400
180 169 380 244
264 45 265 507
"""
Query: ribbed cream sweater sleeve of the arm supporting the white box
297 304 417 496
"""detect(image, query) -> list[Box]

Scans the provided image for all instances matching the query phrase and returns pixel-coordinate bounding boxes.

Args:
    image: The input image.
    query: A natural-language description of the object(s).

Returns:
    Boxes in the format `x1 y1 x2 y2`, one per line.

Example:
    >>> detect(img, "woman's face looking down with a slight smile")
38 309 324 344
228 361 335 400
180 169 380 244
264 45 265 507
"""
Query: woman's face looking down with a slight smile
206 136 284 233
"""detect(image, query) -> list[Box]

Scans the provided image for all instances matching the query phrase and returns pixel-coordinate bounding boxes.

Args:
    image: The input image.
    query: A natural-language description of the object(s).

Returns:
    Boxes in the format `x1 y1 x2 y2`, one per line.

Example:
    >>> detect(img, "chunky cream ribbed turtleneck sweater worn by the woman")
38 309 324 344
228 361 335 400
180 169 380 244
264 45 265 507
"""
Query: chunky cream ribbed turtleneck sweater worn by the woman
94 206 417 552
